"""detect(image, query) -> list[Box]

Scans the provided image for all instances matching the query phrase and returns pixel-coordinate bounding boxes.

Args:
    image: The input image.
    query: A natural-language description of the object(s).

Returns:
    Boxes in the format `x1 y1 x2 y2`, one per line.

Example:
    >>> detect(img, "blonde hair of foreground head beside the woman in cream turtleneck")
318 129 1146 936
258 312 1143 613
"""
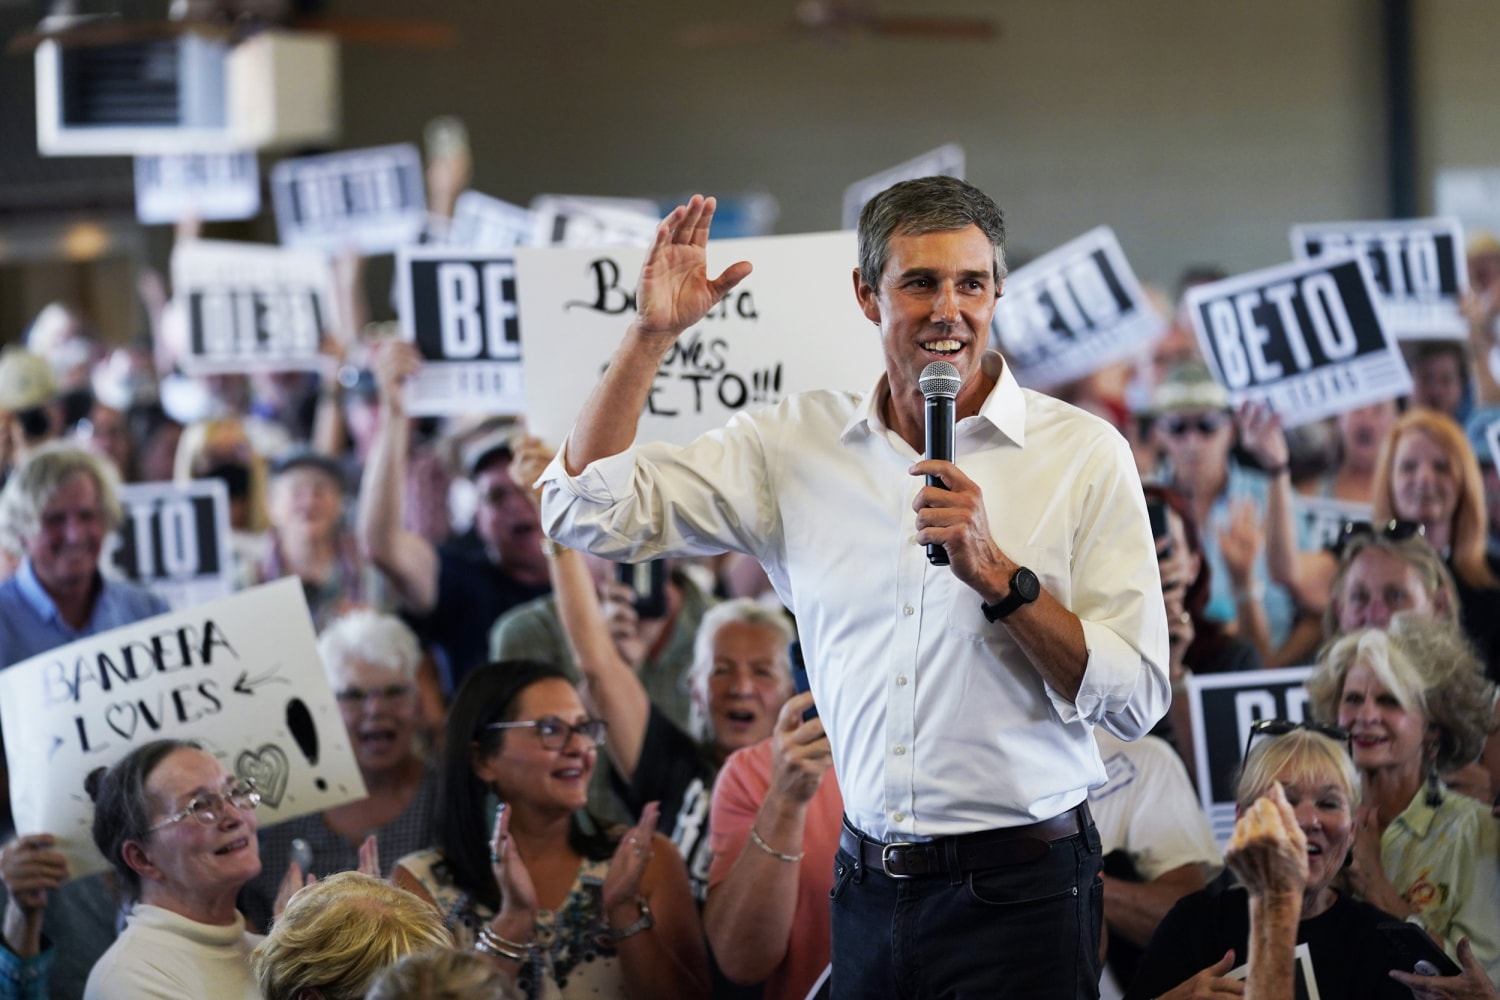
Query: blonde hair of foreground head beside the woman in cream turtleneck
251 871 453 1000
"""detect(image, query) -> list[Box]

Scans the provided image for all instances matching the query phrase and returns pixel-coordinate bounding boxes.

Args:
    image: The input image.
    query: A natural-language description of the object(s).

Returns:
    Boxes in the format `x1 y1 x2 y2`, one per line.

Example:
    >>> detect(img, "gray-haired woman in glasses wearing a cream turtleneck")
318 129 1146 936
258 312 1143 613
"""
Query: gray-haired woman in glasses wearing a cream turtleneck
84 739 261 1000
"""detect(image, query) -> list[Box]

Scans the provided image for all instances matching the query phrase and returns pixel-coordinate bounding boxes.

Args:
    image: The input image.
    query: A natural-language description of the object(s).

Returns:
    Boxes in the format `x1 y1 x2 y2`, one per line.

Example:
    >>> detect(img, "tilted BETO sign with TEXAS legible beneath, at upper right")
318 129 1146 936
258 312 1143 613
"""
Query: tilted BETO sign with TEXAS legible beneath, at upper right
1184 256 1412 427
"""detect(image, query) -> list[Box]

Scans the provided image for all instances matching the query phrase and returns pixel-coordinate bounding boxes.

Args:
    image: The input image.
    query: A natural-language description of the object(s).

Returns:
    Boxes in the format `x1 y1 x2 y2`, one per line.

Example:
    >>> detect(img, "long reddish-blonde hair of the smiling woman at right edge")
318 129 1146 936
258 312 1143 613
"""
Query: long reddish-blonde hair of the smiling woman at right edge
1371 406 1500 586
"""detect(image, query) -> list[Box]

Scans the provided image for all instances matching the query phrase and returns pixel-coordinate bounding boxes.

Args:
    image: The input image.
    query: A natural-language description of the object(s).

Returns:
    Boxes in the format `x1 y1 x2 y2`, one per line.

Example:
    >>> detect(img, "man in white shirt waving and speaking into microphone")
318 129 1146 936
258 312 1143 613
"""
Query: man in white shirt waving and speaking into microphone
542 177 1170 997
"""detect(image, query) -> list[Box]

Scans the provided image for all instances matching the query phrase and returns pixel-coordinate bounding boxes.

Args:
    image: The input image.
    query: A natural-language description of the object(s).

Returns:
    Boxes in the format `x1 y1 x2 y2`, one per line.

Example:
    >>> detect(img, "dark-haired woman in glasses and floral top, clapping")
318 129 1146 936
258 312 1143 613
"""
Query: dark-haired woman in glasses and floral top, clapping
395 661 708 997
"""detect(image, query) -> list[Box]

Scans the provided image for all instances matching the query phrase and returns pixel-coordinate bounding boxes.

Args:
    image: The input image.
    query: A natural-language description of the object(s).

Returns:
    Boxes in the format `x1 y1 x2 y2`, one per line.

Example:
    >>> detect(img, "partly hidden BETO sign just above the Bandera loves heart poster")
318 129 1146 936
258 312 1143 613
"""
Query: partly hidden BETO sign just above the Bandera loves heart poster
105 480 234 610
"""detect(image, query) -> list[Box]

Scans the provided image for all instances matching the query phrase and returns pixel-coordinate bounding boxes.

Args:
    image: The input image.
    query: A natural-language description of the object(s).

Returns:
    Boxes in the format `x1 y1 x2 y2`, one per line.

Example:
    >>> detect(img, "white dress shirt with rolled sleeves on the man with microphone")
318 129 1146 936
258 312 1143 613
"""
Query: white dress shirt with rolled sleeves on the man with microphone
542 354 1170 841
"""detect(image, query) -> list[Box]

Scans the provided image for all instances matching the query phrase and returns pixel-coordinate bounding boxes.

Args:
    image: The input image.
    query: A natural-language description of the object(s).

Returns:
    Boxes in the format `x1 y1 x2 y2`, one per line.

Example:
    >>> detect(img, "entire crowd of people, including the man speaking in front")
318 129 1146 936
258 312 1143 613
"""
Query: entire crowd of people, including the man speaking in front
0 166 1500 1000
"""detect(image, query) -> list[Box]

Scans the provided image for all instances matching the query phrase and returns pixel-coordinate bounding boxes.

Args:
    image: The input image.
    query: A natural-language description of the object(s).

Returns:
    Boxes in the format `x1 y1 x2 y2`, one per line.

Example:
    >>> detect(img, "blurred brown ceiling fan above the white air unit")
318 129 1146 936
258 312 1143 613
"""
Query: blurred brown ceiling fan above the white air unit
6 0 458 52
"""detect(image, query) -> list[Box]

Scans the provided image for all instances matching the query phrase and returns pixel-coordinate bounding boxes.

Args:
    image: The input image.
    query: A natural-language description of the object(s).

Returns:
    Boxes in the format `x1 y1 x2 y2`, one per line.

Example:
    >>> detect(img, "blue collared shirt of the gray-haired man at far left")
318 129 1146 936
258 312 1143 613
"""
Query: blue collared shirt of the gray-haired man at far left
0 559 170 670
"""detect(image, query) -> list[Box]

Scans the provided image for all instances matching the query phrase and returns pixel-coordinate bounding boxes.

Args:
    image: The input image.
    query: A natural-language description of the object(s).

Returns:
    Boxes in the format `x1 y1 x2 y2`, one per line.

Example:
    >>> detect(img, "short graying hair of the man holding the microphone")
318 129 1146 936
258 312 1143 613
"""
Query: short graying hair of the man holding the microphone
860 177 1005 292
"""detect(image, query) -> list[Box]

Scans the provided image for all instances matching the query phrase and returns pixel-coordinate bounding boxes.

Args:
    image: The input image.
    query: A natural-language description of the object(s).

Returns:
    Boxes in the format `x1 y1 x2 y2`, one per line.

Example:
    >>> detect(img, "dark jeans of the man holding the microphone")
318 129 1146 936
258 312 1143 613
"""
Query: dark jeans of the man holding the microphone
833 823 1104 1000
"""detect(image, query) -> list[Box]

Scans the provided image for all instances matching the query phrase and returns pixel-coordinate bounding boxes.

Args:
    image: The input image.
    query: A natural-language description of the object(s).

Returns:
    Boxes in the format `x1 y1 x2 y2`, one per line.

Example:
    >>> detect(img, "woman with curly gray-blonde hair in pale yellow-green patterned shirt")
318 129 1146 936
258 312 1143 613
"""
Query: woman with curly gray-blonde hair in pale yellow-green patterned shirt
1307 615 1500 976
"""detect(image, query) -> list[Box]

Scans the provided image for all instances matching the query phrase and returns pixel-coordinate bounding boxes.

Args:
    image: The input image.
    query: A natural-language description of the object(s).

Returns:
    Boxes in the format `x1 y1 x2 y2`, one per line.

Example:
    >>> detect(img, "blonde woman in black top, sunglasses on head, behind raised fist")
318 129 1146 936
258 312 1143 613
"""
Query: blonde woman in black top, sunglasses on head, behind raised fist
1125 720 1412 1000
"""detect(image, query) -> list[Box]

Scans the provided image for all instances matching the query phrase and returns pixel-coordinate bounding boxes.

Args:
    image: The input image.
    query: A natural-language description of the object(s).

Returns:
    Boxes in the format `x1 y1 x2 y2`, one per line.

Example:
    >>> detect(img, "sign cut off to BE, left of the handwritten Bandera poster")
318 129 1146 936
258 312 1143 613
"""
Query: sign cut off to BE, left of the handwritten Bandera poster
396 246 525 415
